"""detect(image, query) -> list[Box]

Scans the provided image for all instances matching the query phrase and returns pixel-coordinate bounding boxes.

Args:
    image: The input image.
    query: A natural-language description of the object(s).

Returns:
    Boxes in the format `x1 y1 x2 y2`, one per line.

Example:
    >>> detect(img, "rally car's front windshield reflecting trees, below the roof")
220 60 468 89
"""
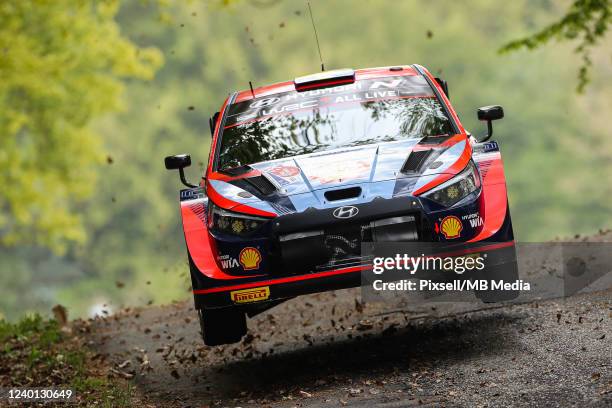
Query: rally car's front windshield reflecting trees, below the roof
218 76 452 171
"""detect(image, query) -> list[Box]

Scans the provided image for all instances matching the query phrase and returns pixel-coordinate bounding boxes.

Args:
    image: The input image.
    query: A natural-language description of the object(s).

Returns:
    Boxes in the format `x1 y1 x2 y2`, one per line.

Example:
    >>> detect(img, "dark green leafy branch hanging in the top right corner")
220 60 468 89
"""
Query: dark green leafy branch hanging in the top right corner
499 0 612 92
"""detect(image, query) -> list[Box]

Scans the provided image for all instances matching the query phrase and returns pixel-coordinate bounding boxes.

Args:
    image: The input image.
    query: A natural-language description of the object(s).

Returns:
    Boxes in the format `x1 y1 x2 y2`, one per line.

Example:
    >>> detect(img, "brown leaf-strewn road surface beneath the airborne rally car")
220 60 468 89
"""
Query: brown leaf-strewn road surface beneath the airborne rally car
94 234 612 407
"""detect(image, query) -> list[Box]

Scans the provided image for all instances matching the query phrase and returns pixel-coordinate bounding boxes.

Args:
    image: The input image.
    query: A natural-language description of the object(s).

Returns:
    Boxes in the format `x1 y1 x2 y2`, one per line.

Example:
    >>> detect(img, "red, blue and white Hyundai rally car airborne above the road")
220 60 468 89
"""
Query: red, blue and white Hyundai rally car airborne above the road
165 65 516 345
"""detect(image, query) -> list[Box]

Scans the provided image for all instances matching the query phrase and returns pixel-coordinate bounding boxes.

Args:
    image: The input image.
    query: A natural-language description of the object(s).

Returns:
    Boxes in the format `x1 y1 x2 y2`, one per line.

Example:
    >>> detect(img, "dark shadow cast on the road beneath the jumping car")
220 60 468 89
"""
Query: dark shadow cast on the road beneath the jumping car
153 312 520 400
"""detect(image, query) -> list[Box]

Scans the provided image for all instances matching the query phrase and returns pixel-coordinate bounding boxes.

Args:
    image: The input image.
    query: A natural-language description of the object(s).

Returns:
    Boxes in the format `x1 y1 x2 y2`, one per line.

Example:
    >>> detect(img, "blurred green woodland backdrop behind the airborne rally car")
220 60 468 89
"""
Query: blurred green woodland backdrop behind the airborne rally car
0 0 612 320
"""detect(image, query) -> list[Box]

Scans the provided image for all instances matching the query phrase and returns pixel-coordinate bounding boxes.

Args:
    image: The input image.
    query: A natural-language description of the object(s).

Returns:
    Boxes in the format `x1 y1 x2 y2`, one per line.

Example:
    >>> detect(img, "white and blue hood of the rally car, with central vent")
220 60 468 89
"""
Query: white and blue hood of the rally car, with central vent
209 138 469 214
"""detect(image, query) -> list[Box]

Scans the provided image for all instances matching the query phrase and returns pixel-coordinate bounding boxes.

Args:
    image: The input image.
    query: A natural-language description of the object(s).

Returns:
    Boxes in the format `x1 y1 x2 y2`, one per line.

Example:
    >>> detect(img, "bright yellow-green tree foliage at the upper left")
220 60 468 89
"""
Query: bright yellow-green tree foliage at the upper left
0 0 162 251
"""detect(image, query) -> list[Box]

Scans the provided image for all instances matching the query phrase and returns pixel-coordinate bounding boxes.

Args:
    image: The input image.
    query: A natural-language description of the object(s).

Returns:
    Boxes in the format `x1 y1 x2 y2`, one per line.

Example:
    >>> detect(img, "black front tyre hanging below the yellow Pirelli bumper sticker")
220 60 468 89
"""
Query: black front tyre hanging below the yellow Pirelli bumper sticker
198 308 247 346
